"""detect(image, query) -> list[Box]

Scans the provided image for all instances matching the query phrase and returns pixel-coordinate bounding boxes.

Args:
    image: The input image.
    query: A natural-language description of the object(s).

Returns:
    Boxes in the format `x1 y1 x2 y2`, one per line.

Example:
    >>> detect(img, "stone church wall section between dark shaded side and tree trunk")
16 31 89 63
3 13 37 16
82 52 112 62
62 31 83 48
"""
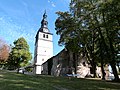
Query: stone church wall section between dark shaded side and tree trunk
51 50 69 76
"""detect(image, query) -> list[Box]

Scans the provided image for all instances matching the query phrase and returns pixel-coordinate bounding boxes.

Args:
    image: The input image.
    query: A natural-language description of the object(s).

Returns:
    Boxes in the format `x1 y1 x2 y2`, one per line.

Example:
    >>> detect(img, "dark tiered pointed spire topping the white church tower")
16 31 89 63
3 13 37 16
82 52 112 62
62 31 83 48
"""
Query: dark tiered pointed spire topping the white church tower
39 11 49 33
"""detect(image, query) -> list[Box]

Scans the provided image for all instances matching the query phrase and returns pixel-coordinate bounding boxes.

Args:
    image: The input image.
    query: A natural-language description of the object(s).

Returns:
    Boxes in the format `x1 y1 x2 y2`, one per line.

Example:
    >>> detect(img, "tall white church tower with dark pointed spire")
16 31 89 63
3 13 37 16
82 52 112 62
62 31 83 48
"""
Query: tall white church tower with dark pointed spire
34 12 53 74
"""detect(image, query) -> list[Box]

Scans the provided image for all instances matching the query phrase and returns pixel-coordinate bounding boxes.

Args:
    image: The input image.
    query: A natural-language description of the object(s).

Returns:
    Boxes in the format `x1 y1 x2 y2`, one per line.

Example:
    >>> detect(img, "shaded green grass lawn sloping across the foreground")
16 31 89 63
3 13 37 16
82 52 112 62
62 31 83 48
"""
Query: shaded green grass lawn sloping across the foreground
0 71 120 90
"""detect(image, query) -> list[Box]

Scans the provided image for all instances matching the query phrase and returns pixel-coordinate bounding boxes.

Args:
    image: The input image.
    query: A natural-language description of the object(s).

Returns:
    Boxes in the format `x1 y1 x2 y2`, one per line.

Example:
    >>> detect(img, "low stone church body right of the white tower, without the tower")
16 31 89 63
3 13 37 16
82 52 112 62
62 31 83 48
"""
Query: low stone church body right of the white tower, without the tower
43 49 90 78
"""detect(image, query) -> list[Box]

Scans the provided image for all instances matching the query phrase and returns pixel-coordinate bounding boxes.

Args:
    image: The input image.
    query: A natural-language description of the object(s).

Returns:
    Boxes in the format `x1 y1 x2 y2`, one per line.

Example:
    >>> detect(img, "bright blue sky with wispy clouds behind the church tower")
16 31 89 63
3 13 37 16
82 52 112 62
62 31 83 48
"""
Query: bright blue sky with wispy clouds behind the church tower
0 0 70 60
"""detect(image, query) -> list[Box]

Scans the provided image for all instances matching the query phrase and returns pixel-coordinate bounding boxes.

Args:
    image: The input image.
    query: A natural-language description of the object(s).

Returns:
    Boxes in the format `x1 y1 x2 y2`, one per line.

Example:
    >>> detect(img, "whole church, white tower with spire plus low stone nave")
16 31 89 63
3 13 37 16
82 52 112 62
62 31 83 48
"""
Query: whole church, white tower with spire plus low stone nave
33 12 104 78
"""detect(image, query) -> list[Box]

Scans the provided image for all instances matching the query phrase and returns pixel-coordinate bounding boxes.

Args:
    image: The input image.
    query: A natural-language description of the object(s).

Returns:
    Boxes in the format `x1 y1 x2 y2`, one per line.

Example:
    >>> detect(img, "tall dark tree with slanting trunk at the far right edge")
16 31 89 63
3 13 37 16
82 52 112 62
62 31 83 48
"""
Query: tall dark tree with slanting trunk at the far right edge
100 0 120 81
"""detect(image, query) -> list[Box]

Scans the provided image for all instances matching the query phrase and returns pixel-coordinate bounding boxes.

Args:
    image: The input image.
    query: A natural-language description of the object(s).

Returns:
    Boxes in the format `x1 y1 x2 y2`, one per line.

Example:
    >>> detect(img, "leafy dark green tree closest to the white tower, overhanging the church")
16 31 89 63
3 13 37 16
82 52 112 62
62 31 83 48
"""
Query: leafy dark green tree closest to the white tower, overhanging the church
55 0 99 77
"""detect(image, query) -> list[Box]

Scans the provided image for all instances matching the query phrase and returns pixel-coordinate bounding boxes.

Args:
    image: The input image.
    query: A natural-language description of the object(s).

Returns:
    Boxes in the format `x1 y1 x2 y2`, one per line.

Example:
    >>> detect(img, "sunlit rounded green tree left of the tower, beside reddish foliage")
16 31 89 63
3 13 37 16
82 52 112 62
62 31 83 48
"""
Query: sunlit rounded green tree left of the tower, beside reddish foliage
8 37 32 71
